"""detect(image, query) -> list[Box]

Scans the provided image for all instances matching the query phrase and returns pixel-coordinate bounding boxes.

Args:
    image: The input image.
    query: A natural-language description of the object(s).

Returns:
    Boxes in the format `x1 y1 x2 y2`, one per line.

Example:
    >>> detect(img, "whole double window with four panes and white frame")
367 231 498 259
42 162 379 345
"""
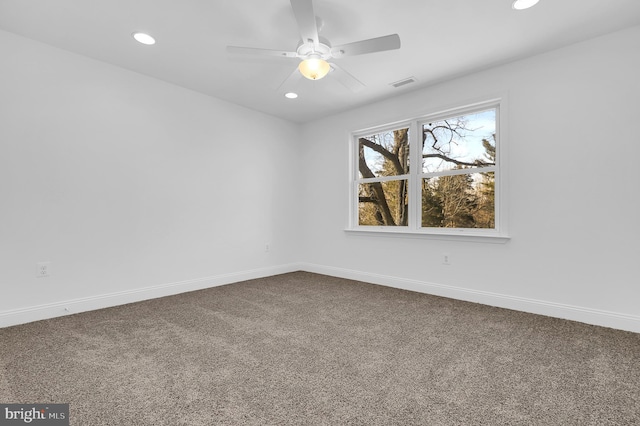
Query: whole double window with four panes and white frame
350 99 506 237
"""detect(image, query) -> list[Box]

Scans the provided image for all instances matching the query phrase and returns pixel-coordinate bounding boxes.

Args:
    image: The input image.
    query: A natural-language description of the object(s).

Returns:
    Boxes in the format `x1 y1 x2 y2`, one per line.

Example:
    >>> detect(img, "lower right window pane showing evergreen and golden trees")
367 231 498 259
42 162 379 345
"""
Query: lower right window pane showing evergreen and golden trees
422 172 496 229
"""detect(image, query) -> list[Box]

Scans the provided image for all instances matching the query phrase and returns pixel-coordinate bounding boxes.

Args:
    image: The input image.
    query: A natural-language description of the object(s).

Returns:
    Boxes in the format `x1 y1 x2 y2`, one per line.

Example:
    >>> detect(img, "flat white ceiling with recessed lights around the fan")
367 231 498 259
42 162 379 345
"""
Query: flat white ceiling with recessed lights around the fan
0 0 640 122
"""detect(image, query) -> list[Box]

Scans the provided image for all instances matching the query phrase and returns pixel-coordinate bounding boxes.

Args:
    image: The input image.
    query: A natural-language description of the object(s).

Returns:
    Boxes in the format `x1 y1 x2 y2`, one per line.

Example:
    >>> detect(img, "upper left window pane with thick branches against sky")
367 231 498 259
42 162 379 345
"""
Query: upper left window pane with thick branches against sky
358 128 409 179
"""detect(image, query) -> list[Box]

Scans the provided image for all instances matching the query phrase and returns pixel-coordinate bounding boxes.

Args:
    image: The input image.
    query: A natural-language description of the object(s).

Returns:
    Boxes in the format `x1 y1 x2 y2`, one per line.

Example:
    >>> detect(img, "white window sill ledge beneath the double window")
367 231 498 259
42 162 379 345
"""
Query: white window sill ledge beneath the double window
344 227 511 244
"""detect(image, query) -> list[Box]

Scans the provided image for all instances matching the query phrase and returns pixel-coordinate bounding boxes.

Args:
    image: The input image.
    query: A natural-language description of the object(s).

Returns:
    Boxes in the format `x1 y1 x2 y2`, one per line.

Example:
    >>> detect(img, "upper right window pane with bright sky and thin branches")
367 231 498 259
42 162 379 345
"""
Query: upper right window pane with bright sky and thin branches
422 109 496 173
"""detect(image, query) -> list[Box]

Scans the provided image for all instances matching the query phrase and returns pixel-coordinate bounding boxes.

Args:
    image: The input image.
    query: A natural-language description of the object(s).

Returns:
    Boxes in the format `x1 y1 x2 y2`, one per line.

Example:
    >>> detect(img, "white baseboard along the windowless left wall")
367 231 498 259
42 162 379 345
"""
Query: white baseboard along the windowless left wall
0 263 300 328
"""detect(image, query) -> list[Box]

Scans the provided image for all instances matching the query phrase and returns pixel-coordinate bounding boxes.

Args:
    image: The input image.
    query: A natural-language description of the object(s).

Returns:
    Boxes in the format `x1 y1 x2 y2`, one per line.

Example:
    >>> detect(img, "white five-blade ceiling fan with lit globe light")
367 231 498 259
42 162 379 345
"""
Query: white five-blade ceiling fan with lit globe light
227 0 400 91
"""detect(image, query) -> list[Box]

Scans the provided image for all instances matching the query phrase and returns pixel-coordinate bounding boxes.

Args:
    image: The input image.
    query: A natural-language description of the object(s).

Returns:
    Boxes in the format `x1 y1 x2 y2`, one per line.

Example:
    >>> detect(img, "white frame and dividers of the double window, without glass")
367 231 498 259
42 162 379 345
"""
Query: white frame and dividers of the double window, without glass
346 95 509 243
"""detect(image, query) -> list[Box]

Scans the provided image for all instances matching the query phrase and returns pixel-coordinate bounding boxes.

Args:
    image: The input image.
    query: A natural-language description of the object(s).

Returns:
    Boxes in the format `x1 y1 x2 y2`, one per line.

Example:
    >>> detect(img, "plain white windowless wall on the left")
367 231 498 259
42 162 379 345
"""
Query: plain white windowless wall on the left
0 32 300 326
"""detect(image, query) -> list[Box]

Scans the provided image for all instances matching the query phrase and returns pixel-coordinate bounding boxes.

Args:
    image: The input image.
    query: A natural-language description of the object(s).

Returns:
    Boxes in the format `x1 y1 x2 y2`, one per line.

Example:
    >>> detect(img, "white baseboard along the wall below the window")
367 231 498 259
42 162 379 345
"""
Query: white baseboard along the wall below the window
299 263 640 333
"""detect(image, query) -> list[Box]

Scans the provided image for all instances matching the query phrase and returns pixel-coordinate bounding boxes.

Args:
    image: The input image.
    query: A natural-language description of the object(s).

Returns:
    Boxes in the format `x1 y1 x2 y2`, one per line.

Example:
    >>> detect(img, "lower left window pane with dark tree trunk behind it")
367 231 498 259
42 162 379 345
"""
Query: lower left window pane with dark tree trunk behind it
358 179 409 226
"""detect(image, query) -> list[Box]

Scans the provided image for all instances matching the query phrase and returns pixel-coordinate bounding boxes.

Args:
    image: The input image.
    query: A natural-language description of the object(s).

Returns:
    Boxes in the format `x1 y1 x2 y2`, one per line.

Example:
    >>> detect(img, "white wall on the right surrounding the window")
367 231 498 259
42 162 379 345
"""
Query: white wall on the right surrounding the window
302 27 640 331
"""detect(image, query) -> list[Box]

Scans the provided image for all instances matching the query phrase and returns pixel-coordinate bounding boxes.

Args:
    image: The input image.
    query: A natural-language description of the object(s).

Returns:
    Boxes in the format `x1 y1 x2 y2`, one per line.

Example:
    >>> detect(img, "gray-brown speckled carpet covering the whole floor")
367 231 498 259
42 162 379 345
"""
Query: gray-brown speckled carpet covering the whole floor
0 272 640 426
